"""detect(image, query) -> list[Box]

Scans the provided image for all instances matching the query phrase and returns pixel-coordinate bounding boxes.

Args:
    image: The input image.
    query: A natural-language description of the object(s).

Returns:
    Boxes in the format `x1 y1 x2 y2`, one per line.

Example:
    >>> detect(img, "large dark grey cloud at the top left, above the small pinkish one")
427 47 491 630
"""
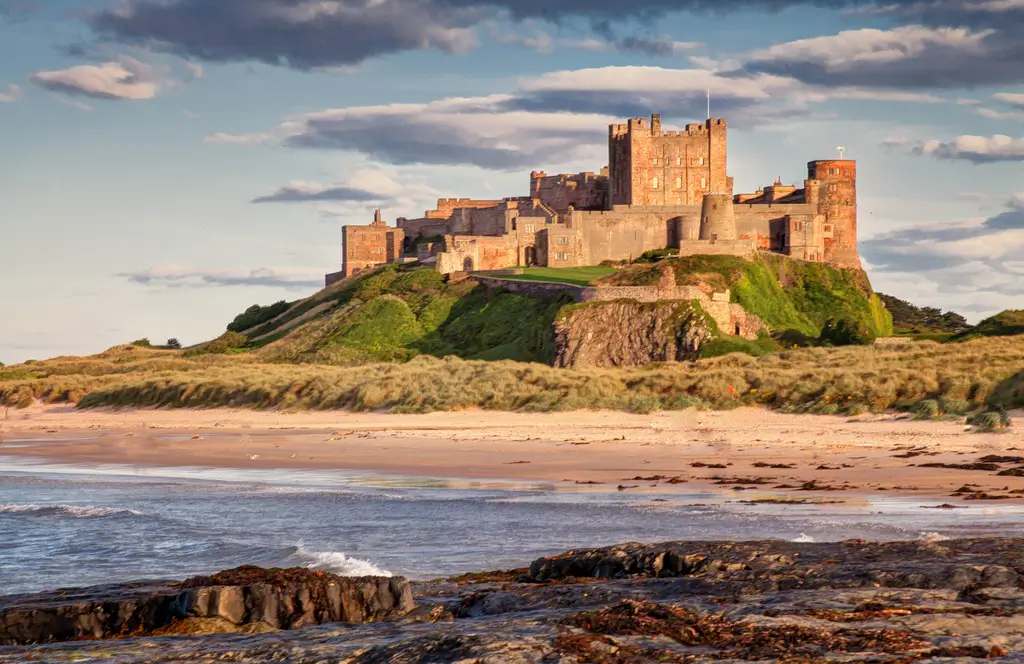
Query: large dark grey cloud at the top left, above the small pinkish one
89 0 479 70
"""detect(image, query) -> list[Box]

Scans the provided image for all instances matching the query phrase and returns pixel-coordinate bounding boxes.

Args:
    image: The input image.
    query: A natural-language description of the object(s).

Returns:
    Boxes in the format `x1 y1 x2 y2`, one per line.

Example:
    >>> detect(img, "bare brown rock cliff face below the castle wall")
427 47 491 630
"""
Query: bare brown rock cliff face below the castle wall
554 300 713 367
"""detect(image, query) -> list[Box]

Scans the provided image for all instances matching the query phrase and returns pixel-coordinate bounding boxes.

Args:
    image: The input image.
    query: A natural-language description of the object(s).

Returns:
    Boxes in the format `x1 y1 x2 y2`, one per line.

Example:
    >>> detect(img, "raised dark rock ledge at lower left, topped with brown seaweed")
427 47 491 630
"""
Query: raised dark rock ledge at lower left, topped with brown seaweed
0 566 413 645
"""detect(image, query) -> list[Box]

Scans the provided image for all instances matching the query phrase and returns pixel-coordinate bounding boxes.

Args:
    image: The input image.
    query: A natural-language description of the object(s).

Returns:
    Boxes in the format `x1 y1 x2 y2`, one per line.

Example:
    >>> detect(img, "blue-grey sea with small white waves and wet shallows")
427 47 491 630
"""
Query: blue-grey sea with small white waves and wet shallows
0 452 1024 594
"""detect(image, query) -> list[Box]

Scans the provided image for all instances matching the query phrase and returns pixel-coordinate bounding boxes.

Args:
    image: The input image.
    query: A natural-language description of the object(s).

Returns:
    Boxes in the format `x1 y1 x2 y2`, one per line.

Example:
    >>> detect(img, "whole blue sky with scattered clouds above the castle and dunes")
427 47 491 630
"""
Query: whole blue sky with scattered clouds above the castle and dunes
0 0 1024 364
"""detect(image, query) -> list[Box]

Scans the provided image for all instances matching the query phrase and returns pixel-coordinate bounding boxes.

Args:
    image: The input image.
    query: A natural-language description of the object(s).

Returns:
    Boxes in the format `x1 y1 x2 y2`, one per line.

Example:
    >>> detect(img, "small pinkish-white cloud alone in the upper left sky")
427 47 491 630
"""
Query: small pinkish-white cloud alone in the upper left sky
30 55 160 100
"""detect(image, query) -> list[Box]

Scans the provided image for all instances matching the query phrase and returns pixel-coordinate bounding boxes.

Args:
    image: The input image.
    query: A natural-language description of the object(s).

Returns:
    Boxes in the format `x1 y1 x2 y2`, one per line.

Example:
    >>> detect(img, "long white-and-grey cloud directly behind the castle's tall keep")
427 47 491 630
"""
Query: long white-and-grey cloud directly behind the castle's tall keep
256 67 940 171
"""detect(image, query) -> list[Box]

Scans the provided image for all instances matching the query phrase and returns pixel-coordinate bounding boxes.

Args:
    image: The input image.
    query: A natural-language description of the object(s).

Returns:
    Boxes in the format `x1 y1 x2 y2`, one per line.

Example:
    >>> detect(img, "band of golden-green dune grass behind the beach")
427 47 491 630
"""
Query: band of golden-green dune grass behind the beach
0 336 1024 414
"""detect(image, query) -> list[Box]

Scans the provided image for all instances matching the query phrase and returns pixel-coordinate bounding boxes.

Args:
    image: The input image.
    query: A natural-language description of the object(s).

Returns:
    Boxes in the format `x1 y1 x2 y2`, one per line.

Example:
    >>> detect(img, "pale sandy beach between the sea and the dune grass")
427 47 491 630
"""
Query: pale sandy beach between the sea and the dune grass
0 407 1024 507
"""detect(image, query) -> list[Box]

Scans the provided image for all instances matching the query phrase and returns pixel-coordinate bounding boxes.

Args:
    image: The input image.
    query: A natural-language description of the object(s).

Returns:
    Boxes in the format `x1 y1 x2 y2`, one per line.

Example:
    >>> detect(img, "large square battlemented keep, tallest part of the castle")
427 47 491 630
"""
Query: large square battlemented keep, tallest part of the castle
608 114 731 207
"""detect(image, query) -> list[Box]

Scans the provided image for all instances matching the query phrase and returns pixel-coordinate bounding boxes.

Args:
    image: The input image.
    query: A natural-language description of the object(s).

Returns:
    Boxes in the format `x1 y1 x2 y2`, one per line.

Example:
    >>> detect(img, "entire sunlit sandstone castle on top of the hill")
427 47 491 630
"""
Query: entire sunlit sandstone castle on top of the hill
327 114 860 285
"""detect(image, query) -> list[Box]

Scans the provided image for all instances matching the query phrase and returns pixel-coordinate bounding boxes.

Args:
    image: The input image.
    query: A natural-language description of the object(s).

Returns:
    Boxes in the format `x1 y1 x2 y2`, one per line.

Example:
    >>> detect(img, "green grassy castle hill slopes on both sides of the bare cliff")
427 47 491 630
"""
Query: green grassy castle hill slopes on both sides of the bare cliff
172 256 892 366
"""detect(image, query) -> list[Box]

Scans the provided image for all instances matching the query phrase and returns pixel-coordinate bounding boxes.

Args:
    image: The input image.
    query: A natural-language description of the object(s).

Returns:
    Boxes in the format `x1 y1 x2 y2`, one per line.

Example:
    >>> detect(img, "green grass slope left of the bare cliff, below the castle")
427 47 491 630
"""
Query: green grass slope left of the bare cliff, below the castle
228 265 566 365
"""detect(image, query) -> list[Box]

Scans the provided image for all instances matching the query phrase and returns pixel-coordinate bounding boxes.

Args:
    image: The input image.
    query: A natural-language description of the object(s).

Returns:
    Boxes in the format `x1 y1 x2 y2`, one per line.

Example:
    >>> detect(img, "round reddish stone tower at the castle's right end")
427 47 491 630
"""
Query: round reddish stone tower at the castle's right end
804 159 860 269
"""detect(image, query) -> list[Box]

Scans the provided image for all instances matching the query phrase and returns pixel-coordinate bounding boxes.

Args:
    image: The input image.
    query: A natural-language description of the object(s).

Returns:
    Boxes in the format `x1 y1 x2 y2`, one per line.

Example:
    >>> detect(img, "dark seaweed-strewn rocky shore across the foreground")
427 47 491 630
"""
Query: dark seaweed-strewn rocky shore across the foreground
0 538 1024 664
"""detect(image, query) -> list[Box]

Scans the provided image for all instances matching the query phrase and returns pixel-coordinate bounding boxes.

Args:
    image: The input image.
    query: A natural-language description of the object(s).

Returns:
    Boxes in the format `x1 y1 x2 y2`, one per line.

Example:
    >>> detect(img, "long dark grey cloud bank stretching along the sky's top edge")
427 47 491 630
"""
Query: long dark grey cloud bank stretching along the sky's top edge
88 0 946 70
